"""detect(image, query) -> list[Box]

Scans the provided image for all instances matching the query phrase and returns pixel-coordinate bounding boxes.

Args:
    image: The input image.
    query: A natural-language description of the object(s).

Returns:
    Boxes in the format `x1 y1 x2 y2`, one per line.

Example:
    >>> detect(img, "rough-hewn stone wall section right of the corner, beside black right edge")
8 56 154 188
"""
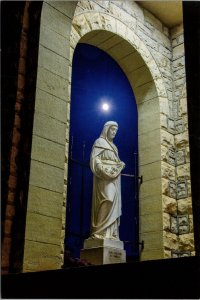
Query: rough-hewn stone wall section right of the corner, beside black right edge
164 25 194 257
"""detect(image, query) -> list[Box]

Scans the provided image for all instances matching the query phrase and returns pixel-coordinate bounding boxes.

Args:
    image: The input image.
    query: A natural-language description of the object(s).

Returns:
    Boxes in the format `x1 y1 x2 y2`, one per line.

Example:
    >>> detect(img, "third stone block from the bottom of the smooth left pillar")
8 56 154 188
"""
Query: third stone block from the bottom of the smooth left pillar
27 184 63 218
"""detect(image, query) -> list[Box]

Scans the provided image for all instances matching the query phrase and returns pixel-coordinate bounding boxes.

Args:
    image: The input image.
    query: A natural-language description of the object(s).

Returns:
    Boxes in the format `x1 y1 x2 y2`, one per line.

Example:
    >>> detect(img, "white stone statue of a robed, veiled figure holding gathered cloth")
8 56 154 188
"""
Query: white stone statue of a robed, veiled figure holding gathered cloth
90 121 125 240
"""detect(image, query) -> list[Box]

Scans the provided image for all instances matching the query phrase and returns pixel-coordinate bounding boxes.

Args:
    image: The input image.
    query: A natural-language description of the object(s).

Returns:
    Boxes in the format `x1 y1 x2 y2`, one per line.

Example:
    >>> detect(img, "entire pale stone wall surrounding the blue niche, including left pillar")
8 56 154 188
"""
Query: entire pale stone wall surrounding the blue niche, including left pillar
24 0 193 271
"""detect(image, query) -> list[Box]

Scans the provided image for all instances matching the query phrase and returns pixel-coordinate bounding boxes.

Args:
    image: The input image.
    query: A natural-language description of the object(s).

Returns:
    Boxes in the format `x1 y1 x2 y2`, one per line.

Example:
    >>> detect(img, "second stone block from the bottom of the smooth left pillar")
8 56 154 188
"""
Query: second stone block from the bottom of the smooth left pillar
25 211 61 246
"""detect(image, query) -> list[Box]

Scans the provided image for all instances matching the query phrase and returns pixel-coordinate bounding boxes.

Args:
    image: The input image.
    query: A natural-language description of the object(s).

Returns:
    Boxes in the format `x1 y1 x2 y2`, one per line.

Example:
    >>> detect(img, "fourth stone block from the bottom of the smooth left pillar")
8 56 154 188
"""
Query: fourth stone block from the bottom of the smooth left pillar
30 160 64 193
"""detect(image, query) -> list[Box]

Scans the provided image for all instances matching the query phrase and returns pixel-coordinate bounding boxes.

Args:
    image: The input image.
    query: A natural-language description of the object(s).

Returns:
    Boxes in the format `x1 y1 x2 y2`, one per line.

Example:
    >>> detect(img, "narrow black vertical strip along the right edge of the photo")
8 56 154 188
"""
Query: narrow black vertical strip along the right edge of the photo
183 1 200 255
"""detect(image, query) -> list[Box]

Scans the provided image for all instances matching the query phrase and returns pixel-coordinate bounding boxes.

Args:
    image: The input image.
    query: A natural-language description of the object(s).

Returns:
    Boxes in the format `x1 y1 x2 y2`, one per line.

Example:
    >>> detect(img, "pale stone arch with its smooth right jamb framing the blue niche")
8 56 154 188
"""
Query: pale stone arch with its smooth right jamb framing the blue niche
64 12 168 260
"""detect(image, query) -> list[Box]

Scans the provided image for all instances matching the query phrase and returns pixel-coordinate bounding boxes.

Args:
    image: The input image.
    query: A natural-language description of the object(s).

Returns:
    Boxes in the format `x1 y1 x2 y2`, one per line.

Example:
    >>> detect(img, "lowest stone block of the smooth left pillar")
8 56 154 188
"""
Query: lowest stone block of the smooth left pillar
23 240 62 272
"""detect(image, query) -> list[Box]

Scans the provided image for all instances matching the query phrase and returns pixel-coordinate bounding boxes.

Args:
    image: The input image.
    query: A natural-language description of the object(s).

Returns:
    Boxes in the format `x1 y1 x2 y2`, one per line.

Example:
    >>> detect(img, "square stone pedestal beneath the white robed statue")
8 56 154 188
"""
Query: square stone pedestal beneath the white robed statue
80 238 126 265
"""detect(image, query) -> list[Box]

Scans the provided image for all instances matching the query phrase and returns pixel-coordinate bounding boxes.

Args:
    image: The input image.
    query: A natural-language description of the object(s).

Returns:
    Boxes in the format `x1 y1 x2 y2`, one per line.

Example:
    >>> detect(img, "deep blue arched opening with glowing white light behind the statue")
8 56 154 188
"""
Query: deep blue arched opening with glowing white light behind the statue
65 43 139 260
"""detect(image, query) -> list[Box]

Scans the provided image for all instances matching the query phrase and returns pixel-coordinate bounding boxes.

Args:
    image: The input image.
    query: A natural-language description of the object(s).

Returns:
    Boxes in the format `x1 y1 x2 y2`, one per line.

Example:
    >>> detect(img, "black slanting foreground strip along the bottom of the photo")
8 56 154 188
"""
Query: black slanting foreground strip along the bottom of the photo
1 257 200 299
